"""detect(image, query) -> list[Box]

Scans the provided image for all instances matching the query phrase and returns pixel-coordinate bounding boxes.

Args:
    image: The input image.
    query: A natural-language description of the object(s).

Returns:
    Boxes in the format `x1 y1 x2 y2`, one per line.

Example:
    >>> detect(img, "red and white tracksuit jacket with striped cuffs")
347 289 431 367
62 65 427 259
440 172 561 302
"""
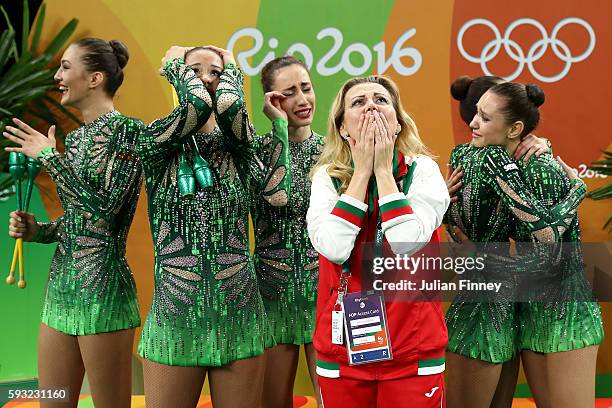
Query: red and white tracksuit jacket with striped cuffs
307 153 450 380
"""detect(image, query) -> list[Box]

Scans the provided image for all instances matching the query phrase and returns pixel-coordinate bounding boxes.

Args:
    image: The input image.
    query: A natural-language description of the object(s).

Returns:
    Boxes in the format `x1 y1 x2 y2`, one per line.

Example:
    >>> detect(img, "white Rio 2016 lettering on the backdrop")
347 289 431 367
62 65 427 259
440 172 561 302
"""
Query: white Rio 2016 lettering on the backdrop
226 27 423 76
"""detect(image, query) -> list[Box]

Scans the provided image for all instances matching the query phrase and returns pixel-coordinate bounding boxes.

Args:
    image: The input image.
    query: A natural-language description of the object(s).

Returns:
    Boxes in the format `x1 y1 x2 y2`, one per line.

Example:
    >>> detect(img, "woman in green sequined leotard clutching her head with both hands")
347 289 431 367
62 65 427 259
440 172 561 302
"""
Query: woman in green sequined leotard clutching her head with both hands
138 46 289 407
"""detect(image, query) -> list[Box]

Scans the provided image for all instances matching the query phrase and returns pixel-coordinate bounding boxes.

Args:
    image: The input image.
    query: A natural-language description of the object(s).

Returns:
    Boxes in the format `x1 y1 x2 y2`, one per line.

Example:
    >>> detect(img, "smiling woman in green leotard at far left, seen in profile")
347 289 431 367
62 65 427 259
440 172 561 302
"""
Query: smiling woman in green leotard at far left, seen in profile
5 38 142 407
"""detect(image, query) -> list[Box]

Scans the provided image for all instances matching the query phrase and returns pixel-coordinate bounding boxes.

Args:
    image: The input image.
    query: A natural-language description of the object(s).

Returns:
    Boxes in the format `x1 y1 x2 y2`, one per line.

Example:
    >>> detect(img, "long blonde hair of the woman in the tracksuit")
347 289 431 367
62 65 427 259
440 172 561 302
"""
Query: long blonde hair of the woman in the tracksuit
310 75 433 193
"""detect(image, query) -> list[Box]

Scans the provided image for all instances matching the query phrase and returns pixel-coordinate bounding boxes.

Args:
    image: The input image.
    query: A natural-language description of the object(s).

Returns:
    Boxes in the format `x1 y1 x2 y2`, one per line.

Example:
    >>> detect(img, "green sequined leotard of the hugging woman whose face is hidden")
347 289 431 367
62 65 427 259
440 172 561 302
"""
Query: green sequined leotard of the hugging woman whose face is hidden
446 144 586 363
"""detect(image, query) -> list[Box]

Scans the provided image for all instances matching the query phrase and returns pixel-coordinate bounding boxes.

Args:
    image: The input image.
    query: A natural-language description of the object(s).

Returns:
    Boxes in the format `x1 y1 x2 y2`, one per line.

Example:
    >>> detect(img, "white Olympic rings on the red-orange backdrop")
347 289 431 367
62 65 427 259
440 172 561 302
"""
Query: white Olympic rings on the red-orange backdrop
457 17 595 82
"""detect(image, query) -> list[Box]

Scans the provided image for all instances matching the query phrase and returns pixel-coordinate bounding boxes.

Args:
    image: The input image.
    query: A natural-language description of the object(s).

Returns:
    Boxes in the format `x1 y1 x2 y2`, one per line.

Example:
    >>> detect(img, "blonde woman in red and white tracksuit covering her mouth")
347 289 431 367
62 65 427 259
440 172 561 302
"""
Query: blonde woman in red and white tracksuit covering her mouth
307 76 450 408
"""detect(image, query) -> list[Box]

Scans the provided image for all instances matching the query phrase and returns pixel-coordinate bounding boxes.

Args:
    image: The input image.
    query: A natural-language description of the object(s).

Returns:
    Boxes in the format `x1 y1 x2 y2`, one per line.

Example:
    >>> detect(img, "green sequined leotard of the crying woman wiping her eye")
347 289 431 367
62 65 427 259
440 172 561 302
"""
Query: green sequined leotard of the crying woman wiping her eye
252 133 323 345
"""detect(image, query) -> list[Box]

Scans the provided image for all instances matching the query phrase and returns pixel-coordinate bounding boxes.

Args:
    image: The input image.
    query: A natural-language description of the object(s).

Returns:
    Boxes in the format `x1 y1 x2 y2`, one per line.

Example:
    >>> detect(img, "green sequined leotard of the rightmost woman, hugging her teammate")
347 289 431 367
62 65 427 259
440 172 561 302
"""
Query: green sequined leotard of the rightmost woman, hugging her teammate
513 154 604 353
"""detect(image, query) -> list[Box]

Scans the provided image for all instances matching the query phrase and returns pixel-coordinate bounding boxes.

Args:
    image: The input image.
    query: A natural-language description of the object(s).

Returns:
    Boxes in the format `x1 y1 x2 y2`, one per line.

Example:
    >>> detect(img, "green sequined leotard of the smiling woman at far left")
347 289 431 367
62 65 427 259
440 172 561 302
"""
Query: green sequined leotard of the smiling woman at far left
34 111 142 335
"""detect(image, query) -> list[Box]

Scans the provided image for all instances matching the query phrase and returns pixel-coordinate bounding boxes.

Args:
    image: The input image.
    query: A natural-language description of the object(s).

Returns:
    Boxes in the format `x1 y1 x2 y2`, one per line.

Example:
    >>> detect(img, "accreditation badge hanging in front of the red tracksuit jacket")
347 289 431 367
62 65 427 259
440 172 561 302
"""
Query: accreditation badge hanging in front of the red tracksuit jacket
342 291 393 365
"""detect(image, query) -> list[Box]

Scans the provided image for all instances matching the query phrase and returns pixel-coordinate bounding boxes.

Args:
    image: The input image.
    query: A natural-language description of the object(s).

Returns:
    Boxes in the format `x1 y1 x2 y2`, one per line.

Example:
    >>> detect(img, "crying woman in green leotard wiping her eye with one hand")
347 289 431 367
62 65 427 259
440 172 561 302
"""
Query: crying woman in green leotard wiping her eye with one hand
252 56 323 408
